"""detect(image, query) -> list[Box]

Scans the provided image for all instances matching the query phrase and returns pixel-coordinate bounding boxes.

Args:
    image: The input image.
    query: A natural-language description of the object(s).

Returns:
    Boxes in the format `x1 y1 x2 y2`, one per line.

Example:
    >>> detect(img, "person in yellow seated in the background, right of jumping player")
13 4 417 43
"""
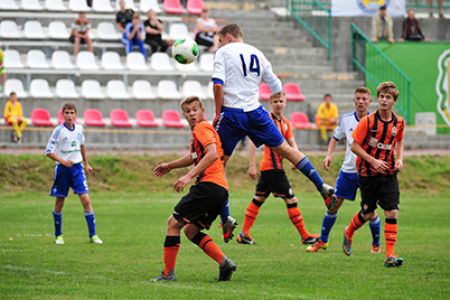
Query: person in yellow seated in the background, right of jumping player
316 94 339 142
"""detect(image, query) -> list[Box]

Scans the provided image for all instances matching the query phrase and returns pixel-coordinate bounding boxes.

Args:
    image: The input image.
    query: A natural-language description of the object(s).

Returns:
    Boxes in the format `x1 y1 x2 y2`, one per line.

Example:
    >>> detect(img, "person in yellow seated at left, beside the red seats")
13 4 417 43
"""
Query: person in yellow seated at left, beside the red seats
3 92 28 143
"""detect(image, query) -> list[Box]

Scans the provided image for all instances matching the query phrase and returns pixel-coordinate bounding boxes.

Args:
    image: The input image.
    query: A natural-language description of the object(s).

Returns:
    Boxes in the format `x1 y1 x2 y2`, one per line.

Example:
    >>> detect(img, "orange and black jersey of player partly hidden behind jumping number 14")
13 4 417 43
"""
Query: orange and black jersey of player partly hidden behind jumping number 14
259 113 294 171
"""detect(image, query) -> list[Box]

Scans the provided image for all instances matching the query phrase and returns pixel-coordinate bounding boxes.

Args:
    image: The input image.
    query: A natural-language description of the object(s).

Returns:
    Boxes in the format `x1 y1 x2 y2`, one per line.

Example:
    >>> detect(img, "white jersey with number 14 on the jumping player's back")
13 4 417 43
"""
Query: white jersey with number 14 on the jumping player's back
212 43 282 111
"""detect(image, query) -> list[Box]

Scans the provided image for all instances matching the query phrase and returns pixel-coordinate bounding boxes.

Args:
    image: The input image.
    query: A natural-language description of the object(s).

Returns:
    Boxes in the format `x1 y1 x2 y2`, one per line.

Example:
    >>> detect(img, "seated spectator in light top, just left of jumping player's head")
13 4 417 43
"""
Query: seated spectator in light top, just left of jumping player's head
195 8 219 52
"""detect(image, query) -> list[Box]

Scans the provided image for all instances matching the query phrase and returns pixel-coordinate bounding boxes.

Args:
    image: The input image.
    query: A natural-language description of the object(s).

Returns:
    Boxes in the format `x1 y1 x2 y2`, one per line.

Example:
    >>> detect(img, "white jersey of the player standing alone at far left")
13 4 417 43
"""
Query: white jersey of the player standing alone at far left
45 123 85 163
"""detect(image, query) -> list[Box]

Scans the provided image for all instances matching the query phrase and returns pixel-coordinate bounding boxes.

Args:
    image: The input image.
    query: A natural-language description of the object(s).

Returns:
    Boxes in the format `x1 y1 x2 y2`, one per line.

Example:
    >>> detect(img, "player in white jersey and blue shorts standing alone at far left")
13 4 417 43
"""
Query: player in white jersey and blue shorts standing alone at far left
45 103 103 245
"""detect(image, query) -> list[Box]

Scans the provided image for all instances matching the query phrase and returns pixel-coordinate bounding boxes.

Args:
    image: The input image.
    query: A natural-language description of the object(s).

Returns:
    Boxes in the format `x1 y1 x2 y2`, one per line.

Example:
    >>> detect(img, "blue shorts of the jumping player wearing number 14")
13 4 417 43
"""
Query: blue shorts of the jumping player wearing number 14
216 106 284 156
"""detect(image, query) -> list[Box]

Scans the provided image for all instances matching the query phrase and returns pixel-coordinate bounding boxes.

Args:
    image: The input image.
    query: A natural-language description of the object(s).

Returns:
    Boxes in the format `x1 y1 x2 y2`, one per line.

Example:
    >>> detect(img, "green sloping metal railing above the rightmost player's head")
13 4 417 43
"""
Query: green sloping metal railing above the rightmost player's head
350 23 412 124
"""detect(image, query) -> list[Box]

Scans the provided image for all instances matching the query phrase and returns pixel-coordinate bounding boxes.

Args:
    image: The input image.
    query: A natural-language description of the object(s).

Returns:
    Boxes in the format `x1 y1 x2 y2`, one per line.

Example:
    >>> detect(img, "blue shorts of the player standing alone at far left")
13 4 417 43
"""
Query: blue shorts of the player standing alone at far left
50 163 89 198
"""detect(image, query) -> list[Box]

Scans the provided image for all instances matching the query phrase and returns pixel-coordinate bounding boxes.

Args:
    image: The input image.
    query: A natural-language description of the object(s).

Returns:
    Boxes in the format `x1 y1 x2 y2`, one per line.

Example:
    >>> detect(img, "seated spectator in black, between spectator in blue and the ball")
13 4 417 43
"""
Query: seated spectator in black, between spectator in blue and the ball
144 9 173 53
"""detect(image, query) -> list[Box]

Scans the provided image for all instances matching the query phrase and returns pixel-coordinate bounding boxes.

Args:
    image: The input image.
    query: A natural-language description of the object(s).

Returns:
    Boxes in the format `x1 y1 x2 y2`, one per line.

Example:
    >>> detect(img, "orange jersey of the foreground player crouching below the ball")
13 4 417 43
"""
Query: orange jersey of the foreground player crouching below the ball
191 121 228 189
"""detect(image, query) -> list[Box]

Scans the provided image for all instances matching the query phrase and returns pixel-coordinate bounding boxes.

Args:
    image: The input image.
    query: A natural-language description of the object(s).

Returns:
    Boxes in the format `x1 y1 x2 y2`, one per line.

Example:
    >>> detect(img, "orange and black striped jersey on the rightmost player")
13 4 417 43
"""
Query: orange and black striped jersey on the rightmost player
352 111 405 176
